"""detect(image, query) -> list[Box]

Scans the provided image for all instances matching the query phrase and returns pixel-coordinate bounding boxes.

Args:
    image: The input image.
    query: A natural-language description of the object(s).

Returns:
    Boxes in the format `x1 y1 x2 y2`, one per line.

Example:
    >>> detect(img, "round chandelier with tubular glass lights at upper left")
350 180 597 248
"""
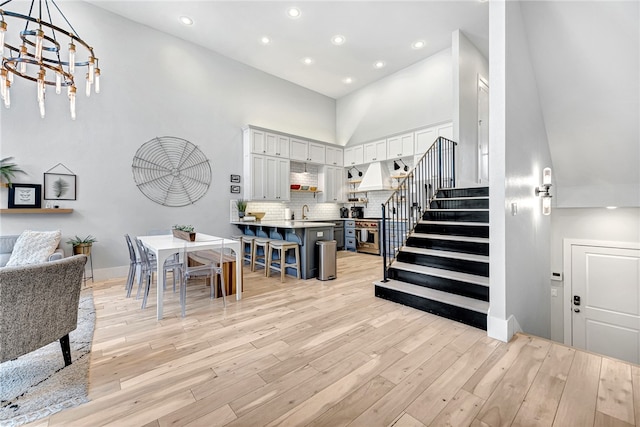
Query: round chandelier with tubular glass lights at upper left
0 0 100 120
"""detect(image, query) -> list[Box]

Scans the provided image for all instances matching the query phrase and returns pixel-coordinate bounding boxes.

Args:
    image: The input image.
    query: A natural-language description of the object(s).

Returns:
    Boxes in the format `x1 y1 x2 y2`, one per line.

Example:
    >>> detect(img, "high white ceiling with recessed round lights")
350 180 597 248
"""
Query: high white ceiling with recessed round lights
88 0 489 98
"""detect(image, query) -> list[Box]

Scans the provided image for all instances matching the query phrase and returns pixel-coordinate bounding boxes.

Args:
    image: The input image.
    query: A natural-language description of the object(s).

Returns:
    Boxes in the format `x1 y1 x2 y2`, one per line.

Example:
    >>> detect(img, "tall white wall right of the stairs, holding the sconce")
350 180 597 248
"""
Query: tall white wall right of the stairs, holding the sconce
489 2 552 339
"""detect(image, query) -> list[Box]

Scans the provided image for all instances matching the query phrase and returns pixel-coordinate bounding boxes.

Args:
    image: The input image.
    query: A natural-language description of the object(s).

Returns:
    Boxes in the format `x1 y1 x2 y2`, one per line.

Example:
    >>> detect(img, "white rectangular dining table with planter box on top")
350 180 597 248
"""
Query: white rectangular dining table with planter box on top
138 233 242 320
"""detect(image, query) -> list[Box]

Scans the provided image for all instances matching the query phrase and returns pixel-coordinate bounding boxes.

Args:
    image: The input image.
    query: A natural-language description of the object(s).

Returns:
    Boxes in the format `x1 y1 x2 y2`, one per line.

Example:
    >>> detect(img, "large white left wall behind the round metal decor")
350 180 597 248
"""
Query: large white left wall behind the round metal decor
0 2 335 279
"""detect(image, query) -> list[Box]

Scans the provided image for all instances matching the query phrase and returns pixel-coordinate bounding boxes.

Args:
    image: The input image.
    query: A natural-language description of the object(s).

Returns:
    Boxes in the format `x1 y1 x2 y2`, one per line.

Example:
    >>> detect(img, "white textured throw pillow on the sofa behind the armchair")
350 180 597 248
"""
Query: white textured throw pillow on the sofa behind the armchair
7 230 62 267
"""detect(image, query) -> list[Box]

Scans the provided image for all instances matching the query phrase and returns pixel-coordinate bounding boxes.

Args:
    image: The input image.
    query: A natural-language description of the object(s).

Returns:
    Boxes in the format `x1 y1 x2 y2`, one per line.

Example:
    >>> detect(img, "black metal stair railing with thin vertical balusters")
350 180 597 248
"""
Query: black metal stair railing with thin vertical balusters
380 136 457 282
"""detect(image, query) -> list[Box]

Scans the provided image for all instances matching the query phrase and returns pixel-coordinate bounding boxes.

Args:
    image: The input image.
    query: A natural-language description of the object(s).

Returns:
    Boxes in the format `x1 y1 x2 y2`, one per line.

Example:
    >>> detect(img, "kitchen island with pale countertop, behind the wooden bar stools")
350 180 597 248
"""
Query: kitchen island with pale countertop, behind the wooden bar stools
231 220 335 279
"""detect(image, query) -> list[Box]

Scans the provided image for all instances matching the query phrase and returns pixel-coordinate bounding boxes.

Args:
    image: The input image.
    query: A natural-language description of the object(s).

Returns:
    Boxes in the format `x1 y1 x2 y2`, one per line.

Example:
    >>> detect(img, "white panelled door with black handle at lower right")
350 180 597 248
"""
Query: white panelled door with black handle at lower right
568 245 640 364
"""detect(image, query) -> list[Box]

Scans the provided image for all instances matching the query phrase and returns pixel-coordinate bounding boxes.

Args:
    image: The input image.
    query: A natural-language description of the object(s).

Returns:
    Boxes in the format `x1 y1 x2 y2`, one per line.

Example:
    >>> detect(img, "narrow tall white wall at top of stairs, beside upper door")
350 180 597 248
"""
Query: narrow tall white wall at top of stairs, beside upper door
453 30 489 187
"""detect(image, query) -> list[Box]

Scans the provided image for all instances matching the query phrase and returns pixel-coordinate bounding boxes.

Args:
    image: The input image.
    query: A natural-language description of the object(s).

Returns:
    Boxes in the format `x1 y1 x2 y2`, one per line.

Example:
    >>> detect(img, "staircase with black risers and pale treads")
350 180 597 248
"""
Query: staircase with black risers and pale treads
375 187 489 330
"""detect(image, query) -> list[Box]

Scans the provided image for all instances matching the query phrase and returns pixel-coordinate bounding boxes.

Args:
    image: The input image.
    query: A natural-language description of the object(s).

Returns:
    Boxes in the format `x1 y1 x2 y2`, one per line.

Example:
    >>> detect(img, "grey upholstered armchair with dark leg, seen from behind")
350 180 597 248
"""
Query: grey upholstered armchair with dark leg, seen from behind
0 255 87 366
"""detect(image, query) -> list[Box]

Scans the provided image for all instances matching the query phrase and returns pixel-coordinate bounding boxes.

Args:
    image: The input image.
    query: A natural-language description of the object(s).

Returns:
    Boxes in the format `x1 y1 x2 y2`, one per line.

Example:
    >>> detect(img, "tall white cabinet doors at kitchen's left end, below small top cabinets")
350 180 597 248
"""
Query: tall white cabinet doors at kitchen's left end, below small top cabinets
245 154 290 201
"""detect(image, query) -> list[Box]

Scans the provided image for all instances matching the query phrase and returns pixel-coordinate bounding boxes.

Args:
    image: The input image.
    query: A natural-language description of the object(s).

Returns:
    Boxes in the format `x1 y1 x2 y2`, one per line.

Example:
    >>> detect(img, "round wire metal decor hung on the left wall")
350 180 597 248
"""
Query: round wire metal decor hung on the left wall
131 136 211 206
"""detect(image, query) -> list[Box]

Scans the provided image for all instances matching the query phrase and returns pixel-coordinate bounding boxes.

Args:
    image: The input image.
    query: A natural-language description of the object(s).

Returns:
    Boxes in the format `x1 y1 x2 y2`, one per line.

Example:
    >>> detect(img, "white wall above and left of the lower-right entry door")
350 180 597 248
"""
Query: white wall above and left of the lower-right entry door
550 208 640 342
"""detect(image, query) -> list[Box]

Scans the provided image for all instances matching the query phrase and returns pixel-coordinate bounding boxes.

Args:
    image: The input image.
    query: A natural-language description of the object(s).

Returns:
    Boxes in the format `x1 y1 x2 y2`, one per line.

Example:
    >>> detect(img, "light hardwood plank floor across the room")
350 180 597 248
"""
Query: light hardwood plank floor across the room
32 252 640 427
